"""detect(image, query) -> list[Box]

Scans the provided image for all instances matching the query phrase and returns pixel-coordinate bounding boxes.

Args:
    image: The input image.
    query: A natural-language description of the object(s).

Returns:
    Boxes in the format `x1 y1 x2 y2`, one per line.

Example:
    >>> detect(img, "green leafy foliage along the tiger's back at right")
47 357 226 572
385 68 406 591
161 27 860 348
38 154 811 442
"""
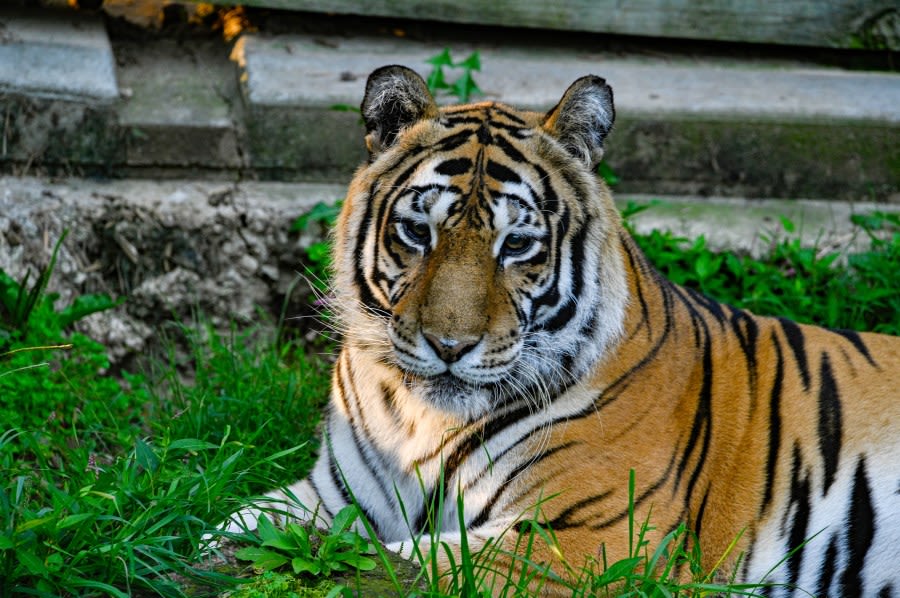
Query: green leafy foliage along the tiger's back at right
624 206 900 335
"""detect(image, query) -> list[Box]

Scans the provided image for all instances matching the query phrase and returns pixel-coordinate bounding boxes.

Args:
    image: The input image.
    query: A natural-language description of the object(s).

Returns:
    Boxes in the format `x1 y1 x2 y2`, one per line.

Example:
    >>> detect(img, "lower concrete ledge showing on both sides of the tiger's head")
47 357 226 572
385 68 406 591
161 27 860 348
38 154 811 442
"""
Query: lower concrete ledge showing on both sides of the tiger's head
0 177 900 361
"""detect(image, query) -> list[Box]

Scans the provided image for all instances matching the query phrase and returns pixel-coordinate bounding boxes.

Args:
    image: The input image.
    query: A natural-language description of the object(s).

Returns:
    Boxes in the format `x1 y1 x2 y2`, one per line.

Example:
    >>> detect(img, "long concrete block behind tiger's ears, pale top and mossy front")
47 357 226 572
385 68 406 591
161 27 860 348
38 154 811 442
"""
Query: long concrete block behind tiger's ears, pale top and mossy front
233 35 900 201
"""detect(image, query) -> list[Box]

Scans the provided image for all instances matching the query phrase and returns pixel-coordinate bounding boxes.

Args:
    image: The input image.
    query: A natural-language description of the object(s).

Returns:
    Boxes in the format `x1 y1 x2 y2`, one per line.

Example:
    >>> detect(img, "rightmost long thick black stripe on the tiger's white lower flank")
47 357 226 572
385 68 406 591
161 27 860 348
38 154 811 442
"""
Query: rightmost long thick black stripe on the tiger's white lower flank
841 457 875 597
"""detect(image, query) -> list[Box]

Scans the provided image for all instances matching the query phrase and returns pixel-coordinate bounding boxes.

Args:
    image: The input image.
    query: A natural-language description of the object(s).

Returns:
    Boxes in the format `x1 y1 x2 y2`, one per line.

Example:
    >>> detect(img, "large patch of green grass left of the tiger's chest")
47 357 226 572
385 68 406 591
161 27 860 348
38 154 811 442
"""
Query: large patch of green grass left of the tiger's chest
0 300 327 596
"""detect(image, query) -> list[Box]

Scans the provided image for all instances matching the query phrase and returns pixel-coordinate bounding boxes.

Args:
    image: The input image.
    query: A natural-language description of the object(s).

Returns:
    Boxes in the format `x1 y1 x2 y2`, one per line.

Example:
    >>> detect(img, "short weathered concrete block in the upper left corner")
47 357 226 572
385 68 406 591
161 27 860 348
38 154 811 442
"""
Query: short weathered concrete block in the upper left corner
0 7 119 171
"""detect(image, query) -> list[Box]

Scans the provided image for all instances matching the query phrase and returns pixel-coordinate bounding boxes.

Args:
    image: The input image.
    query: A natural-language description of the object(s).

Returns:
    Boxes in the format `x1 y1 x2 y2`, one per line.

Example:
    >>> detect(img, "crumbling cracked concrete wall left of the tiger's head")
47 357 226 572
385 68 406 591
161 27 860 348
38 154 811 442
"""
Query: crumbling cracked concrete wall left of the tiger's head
0 178 338 363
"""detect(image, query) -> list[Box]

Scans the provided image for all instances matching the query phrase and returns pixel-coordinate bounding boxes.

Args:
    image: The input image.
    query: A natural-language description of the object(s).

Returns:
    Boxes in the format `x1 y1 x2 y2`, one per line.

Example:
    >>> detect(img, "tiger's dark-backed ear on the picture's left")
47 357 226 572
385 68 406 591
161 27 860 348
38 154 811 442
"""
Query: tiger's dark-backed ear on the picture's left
360 65 438 157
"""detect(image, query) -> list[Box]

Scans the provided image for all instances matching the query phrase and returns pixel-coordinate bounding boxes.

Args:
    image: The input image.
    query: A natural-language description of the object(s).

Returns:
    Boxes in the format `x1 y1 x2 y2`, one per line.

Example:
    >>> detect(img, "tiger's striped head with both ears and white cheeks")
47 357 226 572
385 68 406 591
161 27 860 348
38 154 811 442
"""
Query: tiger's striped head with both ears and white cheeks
334 66 627 421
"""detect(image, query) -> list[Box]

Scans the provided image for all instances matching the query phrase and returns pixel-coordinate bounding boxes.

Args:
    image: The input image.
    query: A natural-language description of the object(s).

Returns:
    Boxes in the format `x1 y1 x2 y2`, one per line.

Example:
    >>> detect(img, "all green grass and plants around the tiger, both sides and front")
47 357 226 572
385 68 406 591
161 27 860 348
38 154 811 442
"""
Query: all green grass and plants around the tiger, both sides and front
0 208 900 596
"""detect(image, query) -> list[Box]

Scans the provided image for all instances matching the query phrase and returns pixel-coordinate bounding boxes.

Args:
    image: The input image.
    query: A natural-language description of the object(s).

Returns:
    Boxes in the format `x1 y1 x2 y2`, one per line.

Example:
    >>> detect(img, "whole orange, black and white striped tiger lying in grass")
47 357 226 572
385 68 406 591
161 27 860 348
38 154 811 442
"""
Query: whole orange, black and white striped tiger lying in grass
225 65 900 597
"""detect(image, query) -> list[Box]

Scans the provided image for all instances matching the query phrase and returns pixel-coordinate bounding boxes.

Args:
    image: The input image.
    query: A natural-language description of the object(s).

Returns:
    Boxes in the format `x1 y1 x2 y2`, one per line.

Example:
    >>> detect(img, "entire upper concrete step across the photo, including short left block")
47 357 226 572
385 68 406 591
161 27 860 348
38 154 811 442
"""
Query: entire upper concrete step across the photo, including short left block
0 6 900 202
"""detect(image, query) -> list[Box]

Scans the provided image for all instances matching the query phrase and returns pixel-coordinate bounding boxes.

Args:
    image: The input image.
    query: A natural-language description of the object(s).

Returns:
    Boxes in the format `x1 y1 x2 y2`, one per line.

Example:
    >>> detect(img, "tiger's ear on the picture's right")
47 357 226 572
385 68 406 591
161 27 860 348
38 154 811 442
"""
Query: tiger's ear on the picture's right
543 75 616 168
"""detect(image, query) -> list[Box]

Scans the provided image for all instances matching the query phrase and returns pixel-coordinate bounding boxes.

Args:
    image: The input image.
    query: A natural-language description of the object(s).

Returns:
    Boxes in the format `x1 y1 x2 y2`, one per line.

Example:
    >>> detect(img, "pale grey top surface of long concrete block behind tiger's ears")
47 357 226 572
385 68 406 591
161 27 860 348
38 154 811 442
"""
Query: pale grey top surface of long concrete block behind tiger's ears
234 34 900 126
